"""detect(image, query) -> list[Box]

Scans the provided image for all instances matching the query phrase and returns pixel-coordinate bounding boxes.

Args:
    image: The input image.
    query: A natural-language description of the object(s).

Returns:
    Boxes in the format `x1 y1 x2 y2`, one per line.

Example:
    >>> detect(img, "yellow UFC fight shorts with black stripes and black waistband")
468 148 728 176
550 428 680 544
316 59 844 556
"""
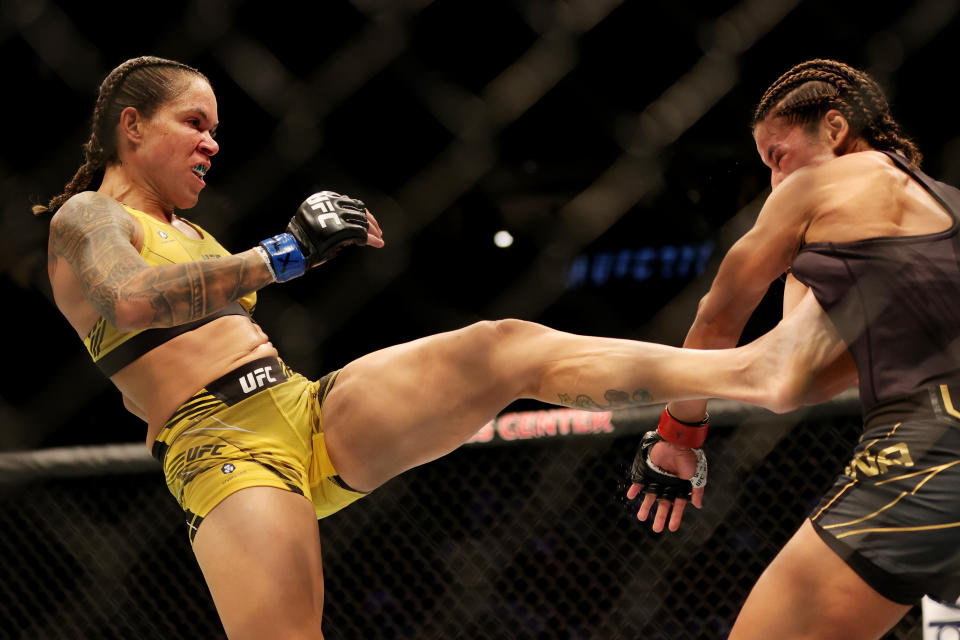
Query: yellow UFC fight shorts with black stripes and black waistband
152 358 367 544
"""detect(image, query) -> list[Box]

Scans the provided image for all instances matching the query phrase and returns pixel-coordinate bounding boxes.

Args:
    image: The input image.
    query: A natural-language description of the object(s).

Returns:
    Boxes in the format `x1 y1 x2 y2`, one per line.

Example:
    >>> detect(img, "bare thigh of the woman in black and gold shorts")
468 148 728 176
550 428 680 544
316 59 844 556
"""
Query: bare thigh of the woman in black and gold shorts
730 520 910 640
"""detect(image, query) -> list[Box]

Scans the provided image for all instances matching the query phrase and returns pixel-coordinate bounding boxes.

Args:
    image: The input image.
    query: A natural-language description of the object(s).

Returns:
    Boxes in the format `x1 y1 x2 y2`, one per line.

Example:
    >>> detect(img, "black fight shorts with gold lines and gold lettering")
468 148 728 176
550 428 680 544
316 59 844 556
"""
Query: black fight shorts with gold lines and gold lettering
811 384 960 604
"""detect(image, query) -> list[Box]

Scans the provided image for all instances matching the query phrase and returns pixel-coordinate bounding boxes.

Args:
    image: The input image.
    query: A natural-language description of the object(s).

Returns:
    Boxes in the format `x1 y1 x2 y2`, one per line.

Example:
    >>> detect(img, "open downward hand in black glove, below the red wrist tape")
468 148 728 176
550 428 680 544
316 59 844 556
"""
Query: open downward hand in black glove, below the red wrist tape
627 431 707 532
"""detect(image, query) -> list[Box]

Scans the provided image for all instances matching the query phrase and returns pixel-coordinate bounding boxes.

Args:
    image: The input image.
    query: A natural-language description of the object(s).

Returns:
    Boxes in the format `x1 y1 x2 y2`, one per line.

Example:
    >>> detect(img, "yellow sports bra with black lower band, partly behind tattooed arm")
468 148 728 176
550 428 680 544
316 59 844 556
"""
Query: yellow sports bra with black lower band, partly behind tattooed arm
83 205 257 377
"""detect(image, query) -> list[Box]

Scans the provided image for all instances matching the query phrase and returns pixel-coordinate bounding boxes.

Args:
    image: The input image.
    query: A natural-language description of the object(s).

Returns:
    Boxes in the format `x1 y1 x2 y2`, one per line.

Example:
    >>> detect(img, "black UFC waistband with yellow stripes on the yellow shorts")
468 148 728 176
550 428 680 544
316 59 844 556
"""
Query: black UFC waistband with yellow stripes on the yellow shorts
150 357 293 463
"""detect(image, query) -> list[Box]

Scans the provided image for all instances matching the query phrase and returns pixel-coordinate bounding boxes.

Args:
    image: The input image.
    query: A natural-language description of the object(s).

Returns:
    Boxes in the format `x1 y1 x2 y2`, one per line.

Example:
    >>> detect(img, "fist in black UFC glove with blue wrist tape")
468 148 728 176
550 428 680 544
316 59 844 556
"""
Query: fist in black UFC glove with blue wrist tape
260 191 370 282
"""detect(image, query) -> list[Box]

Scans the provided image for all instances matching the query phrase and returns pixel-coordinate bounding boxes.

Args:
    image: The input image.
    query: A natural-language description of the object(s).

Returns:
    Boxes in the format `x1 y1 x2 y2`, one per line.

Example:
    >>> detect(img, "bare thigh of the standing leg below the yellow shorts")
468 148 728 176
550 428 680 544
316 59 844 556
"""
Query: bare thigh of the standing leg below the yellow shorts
193 487 323 640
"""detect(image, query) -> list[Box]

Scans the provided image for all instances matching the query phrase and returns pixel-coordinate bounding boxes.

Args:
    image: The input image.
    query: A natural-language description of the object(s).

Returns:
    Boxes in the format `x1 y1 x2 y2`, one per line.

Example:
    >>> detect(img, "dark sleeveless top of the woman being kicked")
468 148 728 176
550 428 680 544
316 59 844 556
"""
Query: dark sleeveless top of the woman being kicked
791 152 960 414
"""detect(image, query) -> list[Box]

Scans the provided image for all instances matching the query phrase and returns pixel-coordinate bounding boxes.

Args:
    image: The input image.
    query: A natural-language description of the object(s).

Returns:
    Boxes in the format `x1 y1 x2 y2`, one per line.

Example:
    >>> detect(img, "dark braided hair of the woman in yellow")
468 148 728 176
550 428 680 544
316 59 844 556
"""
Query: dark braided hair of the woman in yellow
33 56 210 215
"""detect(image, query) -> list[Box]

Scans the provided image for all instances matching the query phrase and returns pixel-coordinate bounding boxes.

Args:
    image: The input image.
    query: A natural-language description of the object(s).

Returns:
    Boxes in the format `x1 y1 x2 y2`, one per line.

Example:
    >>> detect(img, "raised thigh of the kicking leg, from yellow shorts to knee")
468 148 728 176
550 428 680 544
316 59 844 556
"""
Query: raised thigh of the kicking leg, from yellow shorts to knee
321 322 523 491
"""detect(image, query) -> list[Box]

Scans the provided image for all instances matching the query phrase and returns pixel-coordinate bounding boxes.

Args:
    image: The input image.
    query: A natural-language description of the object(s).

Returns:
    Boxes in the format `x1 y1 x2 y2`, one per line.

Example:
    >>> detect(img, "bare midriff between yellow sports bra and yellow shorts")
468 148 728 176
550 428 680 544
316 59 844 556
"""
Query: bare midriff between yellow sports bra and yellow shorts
110 316 277 448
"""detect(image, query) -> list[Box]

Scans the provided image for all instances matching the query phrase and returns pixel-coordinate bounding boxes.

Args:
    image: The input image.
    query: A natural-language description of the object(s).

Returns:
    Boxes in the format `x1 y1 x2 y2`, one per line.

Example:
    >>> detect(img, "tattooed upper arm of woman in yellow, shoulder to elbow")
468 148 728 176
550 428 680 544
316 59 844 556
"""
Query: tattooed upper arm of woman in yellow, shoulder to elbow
50 192 148 325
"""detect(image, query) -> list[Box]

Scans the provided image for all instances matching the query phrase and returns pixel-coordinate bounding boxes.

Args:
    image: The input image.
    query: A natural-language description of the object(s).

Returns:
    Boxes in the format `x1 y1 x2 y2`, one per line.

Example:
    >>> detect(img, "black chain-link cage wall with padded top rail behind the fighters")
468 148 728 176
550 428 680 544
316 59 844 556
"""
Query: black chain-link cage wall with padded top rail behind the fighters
0 396 922 640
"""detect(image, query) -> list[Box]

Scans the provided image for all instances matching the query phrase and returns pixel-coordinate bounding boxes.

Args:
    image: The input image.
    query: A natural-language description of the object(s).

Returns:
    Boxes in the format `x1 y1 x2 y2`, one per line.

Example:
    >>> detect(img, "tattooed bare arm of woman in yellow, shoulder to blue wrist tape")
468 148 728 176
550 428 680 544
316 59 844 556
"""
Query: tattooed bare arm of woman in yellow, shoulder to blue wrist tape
50 192 273 328
